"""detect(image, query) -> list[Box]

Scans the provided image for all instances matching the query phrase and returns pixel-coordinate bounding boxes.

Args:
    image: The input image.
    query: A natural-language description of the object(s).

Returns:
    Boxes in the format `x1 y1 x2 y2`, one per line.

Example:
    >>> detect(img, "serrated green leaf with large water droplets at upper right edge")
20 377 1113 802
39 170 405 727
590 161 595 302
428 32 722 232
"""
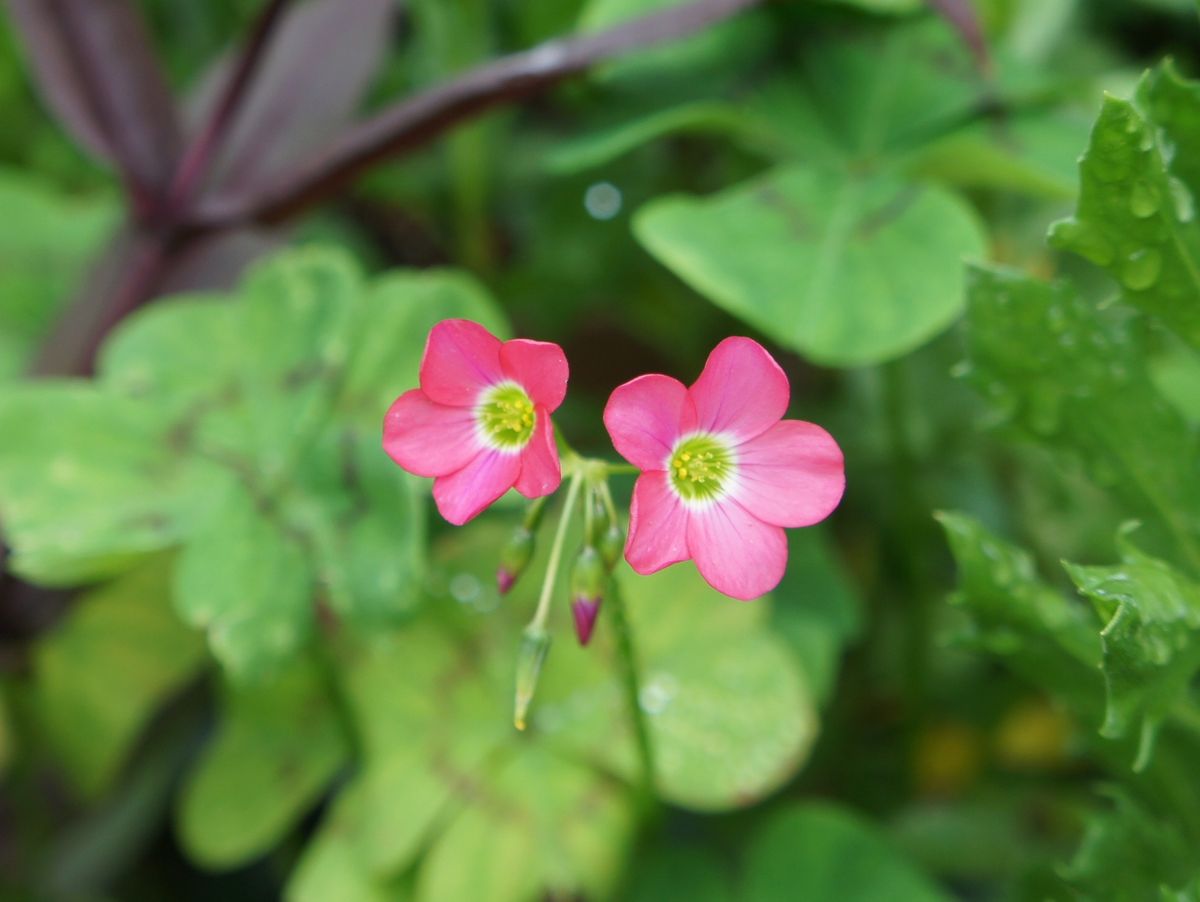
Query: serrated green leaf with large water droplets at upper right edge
1050 66 1200 347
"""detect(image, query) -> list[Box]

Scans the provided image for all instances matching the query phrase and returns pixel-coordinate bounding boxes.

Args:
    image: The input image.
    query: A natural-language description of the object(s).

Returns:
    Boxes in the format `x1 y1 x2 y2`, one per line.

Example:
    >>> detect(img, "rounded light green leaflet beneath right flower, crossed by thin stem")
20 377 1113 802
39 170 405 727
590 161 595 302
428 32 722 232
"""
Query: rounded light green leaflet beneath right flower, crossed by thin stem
534 565 817 810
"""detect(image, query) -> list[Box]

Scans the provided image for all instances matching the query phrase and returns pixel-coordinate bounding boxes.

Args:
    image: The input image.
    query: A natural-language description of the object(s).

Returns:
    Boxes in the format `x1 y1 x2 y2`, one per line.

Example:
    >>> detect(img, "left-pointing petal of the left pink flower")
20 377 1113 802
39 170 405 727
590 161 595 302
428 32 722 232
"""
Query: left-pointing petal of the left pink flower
383 389 484 476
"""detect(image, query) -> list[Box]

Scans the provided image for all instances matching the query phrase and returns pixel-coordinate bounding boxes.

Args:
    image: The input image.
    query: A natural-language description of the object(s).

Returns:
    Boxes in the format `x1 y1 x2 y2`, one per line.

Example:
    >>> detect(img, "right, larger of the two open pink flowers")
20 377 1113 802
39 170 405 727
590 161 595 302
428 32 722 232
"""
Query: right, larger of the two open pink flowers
604 338 846 600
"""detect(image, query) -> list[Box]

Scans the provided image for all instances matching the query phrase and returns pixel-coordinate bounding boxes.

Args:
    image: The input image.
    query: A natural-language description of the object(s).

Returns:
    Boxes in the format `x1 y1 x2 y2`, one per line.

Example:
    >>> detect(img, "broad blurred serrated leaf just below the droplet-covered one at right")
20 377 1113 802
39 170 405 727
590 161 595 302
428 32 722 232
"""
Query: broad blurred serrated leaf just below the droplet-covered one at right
967 263 1200 561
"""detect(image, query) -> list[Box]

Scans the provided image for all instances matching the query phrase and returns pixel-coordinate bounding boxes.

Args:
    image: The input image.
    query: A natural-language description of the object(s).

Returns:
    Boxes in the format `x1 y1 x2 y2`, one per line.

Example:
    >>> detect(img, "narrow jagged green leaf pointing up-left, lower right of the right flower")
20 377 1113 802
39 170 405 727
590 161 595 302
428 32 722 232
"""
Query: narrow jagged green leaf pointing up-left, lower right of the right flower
937 513 1103 710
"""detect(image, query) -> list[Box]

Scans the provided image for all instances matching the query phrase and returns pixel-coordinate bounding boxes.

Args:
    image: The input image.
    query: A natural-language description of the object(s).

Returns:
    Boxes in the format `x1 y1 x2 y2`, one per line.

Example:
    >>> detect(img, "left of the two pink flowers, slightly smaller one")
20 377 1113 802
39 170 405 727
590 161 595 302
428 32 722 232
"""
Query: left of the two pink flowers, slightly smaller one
383 319 568 525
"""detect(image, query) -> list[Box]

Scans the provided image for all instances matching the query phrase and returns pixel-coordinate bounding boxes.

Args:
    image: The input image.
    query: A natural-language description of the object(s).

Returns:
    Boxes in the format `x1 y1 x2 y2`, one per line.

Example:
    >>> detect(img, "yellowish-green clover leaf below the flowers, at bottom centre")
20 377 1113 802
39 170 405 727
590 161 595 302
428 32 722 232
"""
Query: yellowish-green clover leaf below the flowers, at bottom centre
289 524 815 900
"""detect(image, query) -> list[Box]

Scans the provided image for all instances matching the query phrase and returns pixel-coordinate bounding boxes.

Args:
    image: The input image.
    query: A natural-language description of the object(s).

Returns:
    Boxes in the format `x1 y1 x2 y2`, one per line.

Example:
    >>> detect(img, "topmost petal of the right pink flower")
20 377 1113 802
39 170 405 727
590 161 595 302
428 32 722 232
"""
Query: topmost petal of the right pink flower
688 337 791 439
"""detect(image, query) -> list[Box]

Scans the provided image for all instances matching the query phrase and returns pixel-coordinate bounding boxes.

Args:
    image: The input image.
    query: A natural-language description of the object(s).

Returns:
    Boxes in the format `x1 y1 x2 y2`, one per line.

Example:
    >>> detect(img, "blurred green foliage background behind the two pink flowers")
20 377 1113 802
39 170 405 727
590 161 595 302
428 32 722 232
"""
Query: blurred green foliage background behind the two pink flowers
7 0 1200 902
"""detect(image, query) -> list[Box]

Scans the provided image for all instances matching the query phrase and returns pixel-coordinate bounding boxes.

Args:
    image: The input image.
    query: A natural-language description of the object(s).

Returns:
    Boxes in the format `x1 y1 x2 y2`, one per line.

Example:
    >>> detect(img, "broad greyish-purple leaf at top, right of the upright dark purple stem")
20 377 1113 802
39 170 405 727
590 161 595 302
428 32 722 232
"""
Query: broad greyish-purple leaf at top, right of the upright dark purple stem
188 0 397 200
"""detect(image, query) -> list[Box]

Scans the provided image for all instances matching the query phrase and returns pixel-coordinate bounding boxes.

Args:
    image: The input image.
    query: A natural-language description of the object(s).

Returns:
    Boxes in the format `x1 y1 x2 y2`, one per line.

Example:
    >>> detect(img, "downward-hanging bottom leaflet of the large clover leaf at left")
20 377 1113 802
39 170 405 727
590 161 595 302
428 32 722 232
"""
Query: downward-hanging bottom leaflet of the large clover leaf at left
175 488 317 679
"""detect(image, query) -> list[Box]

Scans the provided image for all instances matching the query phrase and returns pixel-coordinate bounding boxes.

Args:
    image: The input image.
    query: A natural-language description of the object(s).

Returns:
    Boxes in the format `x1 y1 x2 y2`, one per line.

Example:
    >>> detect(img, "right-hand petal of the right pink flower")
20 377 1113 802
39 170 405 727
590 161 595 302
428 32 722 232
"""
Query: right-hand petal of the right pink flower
734 420 846 527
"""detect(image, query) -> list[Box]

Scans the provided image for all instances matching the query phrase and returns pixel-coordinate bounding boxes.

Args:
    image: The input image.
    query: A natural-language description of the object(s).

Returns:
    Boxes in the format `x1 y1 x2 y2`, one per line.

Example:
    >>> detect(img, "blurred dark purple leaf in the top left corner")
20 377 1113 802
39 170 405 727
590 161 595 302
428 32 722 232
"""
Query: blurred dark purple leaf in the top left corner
8 0 180 205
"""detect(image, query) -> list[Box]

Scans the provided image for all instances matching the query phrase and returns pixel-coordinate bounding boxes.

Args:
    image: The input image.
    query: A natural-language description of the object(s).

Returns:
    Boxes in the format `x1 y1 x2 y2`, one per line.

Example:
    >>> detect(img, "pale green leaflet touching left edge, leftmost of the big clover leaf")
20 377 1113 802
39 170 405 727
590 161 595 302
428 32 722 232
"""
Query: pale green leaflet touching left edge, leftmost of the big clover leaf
0 383 227 585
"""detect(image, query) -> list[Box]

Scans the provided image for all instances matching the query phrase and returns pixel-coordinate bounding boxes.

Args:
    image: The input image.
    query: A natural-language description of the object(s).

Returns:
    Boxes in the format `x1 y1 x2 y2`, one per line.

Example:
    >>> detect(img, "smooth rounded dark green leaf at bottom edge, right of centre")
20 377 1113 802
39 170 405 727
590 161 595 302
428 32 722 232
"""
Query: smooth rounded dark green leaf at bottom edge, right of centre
742 804 949 902
